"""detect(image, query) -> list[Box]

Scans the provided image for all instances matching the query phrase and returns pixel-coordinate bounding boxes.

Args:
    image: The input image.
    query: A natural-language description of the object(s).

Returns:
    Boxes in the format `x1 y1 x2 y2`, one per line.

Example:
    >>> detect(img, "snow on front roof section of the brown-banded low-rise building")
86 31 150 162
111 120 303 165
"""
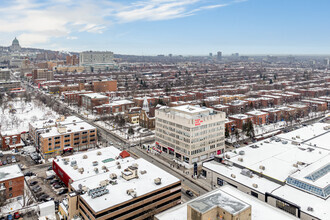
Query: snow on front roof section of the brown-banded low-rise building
71 158 180 212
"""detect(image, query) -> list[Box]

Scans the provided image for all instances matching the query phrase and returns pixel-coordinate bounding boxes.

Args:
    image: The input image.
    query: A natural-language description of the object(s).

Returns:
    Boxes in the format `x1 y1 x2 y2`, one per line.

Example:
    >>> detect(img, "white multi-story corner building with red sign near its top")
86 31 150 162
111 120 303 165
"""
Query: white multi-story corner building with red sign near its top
156 105 225 167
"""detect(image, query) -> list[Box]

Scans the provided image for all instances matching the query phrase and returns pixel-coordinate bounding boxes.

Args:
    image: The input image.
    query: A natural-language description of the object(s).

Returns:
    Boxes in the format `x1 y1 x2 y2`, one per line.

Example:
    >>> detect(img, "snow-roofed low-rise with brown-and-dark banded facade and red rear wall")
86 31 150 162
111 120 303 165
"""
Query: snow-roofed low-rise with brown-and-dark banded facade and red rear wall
53 147 181 220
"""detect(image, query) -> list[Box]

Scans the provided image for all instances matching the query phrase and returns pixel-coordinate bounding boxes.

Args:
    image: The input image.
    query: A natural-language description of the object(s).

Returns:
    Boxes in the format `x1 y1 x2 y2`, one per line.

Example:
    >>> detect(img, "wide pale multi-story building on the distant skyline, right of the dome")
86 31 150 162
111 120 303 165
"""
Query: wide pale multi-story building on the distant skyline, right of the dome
79 51 114 71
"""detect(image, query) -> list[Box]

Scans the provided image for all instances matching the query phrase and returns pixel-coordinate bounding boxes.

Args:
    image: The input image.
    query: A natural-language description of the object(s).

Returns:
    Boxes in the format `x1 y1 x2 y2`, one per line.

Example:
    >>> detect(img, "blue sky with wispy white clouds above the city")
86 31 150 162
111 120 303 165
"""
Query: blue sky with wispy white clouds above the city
0 0 330 55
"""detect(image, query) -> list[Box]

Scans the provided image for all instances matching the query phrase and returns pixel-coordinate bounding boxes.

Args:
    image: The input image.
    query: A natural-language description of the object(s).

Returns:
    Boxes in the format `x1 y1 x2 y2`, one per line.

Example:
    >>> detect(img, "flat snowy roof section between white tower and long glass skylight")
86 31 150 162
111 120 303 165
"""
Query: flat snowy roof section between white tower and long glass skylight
228 141 330 182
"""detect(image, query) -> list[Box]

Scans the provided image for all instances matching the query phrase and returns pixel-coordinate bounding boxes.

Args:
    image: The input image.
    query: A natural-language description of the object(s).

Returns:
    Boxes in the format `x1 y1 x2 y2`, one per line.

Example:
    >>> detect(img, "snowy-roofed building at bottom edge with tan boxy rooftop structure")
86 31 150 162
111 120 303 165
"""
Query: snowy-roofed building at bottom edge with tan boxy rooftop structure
155 186 297 220
